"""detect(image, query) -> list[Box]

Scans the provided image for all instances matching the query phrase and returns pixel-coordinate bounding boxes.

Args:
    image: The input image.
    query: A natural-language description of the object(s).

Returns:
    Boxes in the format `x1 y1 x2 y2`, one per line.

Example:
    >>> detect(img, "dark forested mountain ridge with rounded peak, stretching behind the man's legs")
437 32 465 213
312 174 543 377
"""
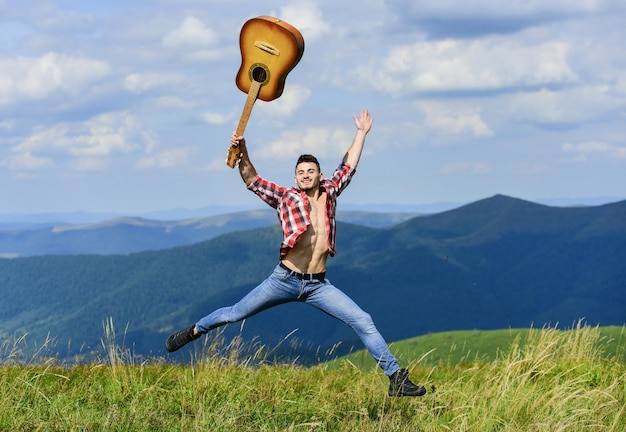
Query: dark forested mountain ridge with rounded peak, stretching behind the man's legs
0 195 626 360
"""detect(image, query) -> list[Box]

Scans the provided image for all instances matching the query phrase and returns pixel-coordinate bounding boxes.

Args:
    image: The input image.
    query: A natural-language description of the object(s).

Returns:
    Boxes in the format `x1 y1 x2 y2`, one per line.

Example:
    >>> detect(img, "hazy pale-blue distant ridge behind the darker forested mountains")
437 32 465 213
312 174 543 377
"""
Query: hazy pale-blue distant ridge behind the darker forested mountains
0 208 417 258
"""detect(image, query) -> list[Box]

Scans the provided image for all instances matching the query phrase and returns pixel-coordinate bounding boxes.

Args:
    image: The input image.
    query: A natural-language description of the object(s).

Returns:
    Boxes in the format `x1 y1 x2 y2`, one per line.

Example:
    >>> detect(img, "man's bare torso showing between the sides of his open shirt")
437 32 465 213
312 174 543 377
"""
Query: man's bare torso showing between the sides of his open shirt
283 192 328 273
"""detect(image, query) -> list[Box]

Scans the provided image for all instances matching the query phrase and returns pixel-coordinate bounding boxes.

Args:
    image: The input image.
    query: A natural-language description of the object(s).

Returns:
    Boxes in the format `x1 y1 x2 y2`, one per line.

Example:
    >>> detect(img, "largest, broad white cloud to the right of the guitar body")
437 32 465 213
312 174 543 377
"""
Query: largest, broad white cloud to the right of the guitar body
346 37 576 95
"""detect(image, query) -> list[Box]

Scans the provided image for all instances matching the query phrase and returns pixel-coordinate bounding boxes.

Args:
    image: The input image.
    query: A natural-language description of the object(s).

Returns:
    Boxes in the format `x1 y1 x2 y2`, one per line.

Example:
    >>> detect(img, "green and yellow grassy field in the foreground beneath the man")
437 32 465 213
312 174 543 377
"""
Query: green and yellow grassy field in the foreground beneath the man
0 326 626 432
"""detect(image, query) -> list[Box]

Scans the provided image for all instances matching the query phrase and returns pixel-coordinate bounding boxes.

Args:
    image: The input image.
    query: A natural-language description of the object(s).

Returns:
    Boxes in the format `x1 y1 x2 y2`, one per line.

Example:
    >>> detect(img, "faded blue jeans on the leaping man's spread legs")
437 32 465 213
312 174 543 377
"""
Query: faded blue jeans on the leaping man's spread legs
196 265 398 376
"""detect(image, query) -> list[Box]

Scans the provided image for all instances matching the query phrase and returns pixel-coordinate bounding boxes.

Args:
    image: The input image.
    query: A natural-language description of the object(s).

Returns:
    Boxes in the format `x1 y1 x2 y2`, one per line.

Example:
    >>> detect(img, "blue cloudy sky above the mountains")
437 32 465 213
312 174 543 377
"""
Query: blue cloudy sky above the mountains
0 0 626 215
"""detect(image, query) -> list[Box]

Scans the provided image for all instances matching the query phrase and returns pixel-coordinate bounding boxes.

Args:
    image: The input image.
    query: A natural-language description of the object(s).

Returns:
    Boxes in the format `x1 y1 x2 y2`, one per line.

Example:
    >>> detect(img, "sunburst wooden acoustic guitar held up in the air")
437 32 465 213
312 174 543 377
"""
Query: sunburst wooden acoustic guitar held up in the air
226 16 304 168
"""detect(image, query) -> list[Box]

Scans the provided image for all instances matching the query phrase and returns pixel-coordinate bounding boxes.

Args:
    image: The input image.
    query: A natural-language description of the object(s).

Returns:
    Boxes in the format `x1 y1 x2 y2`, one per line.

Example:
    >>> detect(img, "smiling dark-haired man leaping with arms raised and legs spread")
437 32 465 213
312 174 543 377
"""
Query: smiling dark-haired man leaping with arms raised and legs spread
166 110 426 396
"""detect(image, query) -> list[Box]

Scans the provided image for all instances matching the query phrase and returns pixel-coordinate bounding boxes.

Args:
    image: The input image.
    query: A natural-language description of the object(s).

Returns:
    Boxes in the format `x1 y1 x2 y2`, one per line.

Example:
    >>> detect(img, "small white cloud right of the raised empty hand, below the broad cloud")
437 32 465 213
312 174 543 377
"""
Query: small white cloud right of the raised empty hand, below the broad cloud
416 100 494 137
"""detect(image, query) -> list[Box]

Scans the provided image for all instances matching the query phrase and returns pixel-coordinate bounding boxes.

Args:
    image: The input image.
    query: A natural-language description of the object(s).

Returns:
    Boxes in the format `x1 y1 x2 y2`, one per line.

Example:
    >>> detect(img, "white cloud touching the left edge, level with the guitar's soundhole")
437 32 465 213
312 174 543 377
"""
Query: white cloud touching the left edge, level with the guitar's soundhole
0 53 110 105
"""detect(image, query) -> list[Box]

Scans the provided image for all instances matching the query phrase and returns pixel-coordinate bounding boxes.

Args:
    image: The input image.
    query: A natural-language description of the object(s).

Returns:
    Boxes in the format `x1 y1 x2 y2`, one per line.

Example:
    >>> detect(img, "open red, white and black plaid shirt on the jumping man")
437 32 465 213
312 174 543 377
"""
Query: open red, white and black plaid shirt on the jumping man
248 162 356 259
